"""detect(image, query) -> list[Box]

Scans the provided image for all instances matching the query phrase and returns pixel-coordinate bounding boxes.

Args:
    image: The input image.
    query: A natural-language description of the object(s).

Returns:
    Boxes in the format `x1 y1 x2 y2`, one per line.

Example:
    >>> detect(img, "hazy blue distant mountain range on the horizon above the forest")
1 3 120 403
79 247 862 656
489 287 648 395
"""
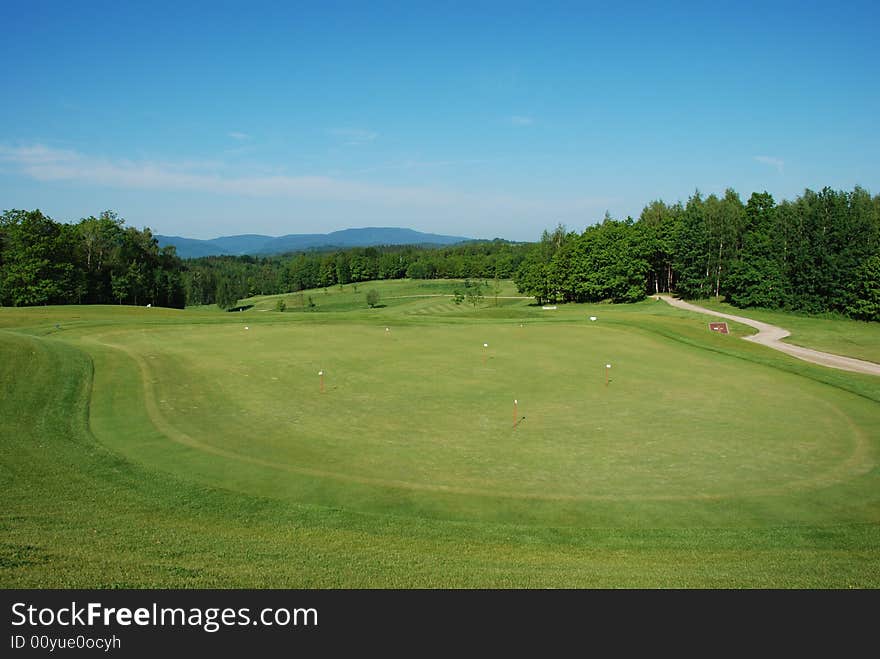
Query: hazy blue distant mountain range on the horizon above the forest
156 227 472 259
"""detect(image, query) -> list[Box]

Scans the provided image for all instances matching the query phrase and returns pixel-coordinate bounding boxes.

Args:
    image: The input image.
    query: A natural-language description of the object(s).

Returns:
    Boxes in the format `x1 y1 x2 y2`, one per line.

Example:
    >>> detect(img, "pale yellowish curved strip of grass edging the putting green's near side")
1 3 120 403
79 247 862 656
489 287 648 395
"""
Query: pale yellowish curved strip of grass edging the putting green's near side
81 320 873 502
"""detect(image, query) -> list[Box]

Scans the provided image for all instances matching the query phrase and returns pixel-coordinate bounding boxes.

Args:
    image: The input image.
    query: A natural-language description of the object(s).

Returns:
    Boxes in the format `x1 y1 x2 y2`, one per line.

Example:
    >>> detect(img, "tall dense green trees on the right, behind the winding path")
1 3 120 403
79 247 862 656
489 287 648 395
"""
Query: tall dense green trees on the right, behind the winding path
514 187 880 320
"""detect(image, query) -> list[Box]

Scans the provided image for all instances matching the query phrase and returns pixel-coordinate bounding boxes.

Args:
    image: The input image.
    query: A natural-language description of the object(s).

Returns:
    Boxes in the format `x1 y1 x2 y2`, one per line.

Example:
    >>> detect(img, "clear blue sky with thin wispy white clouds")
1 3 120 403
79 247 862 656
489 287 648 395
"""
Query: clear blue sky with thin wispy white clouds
0 0 880 240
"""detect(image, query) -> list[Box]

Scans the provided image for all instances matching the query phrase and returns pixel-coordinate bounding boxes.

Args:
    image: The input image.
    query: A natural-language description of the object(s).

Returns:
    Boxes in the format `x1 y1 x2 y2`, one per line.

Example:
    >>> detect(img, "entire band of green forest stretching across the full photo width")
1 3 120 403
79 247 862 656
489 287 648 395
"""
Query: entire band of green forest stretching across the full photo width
0 187 880 320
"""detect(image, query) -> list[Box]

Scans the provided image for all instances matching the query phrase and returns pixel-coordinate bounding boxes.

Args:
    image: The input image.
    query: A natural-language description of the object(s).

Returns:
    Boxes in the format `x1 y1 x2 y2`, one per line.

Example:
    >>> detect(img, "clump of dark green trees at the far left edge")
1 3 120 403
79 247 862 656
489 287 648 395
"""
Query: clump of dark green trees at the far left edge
0 210 185 308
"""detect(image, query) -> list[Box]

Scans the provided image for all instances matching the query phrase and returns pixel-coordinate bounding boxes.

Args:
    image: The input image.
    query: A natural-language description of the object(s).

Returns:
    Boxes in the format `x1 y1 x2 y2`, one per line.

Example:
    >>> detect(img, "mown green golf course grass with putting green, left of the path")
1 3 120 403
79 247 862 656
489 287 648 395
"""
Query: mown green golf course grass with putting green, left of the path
0 282 880 587
